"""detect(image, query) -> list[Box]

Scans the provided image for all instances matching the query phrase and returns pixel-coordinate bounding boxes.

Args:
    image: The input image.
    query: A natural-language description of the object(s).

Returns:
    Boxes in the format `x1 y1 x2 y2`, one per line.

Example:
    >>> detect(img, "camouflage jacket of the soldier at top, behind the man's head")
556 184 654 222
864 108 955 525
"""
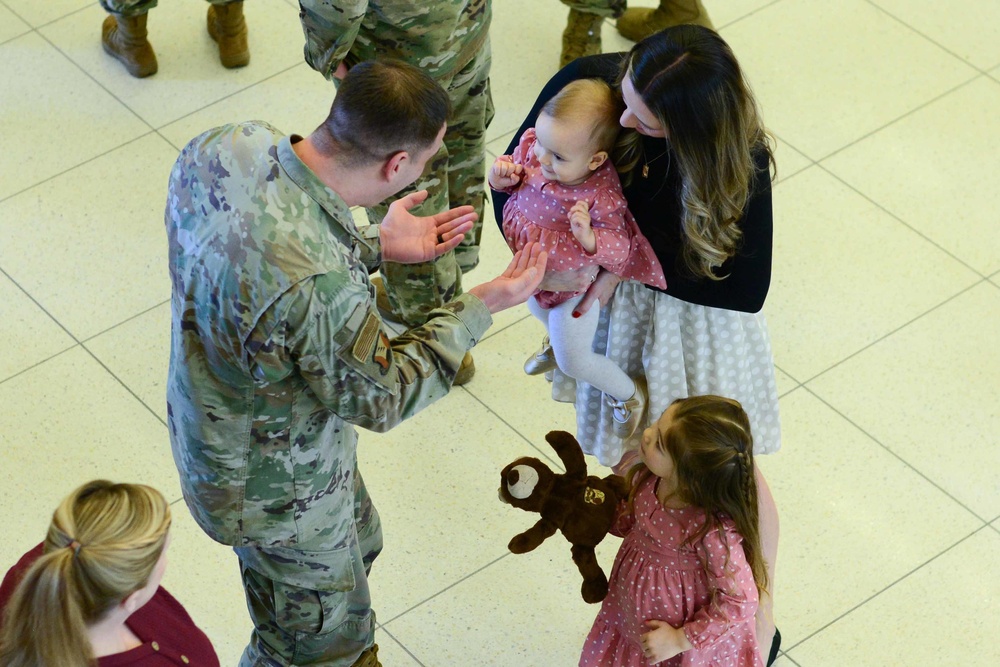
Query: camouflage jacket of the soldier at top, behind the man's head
299 0 492 80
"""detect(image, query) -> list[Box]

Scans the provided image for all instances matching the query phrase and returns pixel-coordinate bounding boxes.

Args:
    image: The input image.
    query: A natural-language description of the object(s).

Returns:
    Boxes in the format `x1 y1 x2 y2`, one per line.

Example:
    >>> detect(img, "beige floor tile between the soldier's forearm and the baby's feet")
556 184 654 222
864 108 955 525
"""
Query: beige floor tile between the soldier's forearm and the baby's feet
467 316 576 446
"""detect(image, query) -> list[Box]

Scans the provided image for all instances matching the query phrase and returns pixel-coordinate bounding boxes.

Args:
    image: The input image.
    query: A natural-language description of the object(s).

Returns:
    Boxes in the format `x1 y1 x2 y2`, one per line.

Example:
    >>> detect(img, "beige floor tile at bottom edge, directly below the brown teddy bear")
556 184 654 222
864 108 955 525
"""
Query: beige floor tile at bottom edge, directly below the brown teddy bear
386 535 621 667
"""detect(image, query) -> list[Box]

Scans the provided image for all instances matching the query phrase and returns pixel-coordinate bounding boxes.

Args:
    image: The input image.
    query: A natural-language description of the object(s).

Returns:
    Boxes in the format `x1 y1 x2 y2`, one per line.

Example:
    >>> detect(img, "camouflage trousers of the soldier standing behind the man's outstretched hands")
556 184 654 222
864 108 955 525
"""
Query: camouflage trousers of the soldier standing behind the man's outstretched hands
368 41 493 326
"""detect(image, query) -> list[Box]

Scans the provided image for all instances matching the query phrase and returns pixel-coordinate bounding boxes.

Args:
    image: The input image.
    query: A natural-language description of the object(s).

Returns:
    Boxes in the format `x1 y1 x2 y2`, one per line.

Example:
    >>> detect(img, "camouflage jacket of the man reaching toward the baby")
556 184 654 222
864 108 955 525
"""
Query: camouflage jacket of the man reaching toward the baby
165 122 492 588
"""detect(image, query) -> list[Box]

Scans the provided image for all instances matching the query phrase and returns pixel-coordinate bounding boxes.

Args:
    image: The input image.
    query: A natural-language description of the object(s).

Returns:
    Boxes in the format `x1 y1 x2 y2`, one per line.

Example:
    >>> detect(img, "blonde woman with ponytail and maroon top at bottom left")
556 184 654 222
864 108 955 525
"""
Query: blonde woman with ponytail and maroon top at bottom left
0 480 219 667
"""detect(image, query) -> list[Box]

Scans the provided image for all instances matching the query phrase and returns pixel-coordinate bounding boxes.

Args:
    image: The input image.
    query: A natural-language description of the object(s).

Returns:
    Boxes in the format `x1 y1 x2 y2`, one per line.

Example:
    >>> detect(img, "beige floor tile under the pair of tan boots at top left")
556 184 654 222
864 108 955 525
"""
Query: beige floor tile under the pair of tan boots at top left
41 0 303 129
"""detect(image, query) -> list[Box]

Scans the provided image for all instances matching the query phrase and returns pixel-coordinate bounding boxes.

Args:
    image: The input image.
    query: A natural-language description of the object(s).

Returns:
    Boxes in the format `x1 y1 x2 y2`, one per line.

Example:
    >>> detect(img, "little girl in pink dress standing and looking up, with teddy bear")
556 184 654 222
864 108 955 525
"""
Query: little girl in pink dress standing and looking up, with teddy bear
580 396 767 667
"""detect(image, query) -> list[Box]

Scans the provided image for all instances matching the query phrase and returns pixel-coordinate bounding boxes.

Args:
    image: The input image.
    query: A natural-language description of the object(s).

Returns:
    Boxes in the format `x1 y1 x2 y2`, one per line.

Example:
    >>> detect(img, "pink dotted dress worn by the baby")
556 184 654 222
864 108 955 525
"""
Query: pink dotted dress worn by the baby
503 128 667 308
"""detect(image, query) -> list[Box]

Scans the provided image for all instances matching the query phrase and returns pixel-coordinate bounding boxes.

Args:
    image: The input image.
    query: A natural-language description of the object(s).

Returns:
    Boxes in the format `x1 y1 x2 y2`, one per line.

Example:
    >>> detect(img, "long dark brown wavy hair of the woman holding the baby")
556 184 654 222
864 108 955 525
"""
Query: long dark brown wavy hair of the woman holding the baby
616 25 774 280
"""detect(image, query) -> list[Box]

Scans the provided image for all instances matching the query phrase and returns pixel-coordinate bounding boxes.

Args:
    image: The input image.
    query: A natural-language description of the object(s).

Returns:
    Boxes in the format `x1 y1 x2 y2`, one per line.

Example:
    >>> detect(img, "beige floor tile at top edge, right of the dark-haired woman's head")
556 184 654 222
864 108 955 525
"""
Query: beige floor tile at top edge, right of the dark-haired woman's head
724 0 976 160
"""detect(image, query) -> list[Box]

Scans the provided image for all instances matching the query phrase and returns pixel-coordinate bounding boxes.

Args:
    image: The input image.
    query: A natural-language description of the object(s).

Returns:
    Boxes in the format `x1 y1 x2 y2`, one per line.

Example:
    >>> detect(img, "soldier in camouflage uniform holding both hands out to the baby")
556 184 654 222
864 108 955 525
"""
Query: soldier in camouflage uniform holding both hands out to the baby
165 61 545 667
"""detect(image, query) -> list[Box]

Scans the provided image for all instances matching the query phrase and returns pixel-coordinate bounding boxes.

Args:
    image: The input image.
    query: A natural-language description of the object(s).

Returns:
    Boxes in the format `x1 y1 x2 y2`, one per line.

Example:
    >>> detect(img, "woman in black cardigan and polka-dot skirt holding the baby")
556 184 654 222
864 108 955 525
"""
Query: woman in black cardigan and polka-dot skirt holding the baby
494 25 781 657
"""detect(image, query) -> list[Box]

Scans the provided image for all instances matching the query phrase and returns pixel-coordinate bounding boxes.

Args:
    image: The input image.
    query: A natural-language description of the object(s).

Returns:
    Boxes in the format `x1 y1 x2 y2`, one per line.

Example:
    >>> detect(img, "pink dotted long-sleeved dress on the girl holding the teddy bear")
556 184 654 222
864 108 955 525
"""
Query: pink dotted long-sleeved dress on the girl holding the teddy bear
580 476 764 667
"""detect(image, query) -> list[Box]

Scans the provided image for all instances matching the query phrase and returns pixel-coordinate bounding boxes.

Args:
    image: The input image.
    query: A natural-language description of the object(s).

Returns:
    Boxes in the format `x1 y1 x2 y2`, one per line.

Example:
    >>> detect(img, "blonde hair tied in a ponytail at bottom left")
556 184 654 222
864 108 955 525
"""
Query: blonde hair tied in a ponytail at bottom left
0 480 170 667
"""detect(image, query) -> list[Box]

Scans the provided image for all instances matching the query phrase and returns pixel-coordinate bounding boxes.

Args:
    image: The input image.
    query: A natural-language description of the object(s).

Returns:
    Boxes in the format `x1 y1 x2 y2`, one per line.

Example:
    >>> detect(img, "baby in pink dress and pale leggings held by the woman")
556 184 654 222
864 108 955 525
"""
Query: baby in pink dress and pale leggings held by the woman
489 79 666 438
